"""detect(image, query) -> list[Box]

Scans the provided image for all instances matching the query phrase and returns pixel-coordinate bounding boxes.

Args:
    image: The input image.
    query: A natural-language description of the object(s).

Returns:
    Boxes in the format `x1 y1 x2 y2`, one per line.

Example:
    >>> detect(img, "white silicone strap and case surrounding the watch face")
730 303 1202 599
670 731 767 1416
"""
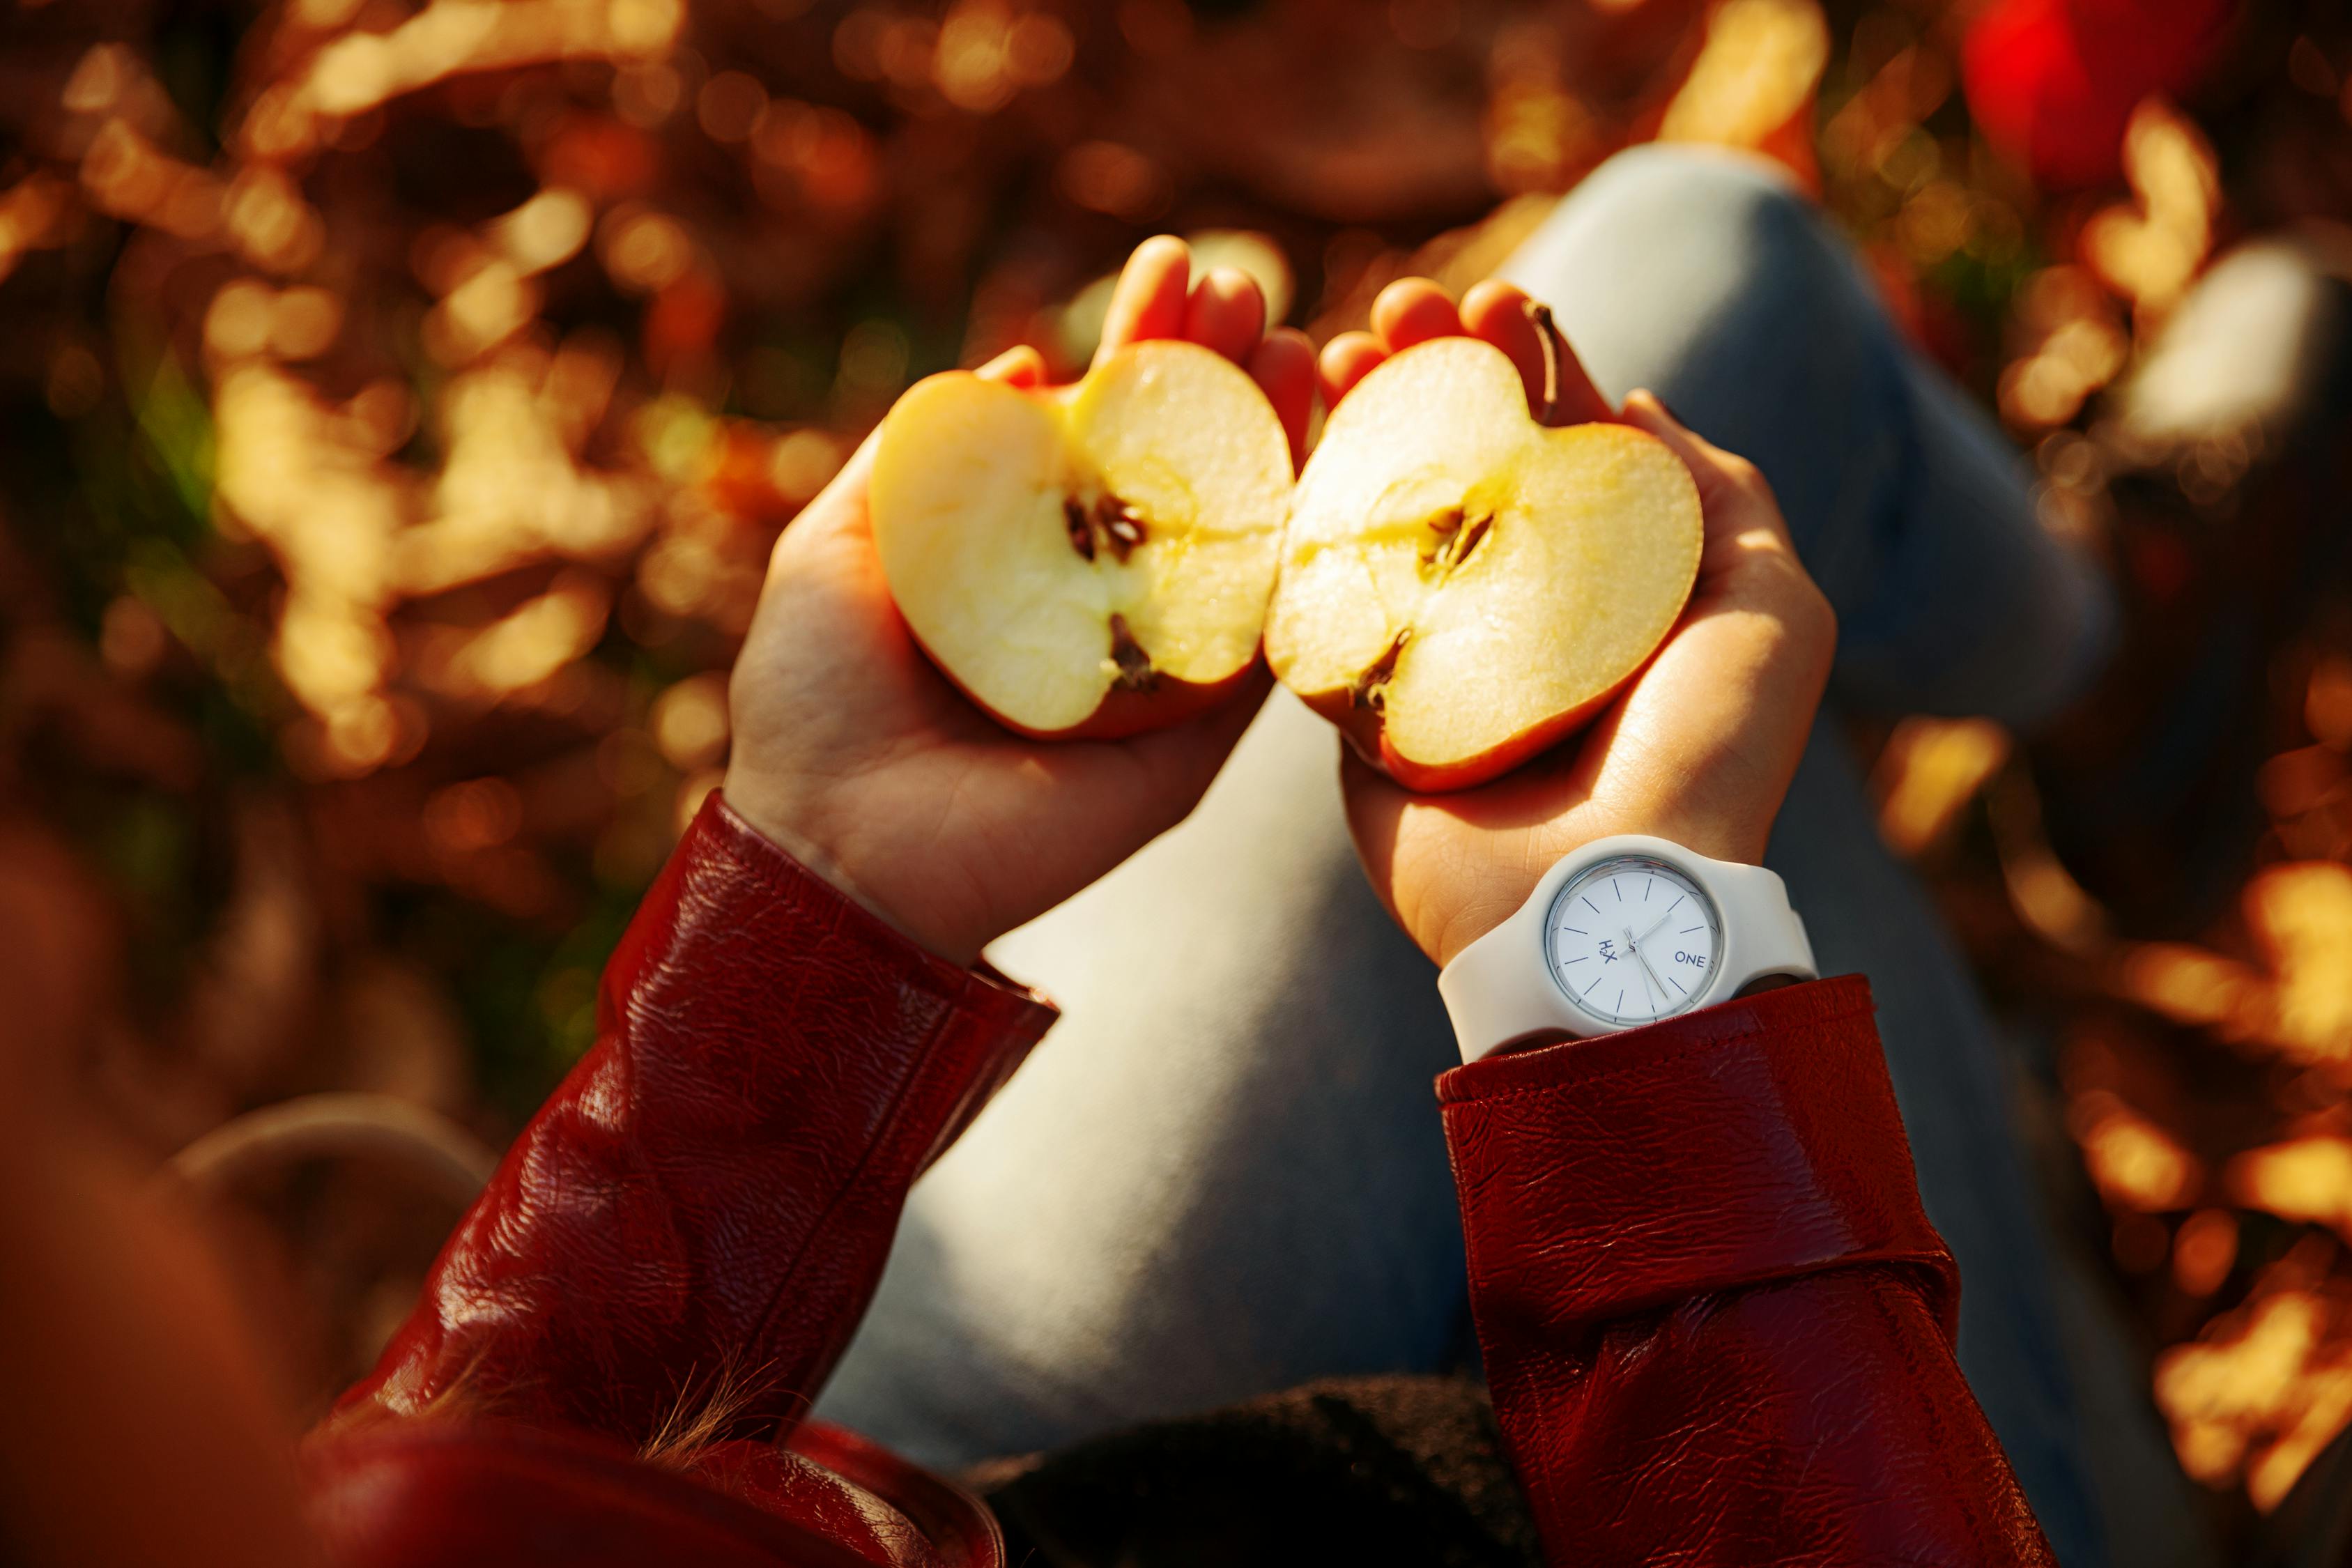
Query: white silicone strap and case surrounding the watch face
1437 835 1816 1063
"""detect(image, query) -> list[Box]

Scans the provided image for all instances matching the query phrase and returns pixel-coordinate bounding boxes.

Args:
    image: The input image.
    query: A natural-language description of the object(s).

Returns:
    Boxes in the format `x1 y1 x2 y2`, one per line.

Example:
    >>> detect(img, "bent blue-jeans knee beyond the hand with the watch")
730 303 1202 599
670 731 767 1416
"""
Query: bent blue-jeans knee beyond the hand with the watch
1503 146 2114 724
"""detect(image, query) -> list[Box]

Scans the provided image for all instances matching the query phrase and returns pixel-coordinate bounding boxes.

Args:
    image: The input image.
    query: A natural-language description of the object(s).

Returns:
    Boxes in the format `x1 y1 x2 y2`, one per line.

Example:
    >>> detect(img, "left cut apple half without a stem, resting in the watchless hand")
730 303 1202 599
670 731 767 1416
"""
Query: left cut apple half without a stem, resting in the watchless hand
868 341 1291 738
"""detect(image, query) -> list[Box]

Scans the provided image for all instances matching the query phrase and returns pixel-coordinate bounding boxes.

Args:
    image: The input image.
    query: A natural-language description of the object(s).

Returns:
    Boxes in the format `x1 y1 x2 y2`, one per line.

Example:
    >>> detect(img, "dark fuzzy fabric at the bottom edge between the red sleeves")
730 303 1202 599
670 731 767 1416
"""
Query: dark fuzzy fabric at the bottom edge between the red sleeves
964 1378 1543 1568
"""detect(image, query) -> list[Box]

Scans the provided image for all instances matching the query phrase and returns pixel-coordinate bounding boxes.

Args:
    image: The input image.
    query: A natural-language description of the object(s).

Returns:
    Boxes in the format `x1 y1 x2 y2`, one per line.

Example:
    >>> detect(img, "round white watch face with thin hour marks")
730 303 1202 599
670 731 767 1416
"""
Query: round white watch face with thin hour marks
1543 856 1724 1025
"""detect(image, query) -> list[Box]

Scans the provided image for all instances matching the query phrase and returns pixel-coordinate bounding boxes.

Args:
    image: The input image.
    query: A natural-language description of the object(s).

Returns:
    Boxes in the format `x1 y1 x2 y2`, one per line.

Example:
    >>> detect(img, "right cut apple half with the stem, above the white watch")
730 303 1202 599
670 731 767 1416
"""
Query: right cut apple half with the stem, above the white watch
1266 336 1703 790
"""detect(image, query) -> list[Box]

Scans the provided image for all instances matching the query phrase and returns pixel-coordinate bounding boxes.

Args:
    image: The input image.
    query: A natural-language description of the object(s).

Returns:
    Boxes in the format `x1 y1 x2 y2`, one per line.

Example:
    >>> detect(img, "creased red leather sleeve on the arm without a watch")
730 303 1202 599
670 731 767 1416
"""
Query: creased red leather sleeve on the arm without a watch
344 794 1054 1443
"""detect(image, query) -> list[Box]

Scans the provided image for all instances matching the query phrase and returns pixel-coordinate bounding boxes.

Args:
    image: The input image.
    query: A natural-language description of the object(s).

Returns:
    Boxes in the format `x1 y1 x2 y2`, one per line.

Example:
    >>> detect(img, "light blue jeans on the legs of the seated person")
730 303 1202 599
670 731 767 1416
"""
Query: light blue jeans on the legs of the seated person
819 148 2204 1568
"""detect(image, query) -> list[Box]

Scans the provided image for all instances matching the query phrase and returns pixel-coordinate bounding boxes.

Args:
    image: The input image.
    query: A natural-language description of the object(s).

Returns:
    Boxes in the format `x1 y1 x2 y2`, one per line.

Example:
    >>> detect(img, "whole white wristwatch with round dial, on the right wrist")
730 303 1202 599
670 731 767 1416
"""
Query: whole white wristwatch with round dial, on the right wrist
1437 835 1818 1063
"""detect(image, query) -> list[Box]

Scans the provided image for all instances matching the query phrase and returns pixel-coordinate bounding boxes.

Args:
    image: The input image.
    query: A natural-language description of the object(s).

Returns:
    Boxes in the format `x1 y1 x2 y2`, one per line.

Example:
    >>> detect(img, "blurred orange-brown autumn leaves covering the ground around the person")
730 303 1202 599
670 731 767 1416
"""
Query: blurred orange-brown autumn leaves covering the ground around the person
0 0 2352 1542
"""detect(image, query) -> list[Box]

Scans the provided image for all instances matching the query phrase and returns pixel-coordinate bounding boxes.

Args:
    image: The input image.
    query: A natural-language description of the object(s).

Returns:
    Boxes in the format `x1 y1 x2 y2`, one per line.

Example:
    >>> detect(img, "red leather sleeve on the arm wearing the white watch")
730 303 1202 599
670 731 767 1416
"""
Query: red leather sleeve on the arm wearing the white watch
1440 978 2051 1568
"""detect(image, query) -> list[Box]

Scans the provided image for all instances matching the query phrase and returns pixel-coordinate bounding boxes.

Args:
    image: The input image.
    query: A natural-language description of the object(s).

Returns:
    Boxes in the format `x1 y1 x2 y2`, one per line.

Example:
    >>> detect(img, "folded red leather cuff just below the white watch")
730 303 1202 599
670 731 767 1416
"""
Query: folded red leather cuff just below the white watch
1437 976 1959 1337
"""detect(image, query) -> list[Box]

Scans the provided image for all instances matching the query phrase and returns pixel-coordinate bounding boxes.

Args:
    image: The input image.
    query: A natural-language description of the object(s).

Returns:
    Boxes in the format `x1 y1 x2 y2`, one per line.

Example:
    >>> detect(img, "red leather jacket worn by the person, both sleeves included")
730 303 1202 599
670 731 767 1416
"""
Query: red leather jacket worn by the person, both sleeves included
306 799 2051 1568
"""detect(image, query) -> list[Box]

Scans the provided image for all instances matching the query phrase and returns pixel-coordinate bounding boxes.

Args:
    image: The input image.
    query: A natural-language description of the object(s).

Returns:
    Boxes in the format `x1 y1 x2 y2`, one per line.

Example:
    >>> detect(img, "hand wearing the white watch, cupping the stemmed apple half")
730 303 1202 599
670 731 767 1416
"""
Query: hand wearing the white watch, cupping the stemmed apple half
1322 277 1837 964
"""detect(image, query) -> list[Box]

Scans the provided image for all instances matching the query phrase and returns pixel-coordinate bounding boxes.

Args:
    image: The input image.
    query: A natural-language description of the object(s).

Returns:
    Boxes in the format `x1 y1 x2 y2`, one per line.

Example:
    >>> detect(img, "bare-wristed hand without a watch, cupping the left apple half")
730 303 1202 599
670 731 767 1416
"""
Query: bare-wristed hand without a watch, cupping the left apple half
727 235 1315 964
